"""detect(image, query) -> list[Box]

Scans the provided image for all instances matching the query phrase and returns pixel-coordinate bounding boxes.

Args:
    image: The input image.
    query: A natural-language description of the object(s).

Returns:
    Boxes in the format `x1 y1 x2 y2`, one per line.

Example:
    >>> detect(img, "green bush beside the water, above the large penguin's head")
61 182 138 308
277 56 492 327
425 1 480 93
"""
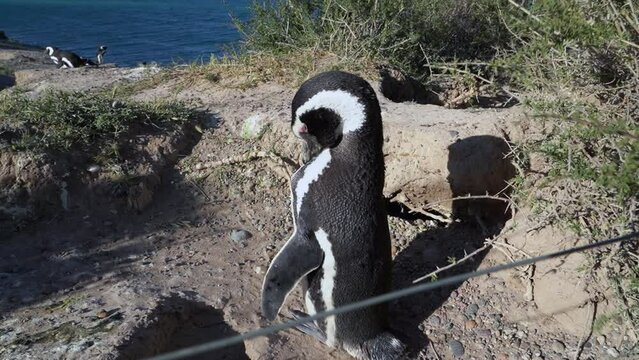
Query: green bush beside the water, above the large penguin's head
239 0 510 72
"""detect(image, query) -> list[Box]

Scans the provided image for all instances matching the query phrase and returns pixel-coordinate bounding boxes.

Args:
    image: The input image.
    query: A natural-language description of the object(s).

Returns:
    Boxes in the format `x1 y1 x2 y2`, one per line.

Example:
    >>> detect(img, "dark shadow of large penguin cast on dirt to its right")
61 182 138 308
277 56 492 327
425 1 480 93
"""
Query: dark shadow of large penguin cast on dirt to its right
390 136 515 358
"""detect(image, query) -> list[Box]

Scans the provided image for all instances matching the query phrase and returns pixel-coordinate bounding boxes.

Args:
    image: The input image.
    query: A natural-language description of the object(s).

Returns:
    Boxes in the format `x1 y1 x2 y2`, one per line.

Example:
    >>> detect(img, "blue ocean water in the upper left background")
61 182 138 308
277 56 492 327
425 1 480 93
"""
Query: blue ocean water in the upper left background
0 0 251 66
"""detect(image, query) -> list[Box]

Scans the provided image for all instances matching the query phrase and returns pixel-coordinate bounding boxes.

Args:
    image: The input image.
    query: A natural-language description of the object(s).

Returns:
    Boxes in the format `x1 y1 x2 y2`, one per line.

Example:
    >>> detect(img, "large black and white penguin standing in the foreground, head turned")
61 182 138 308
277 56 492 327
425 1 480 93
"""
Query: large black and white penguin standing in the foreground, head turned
262 71 405 360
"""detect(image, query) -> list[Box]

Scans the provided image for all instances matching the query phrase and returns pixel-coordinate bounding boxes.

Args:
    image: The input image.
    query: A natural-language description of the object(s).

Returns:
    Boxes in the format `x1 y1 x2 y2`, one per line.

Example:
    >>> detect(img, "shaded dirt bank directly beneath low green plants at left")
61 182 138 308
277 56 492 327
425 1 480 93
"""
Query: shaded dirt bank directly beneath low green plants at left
0 119 200 234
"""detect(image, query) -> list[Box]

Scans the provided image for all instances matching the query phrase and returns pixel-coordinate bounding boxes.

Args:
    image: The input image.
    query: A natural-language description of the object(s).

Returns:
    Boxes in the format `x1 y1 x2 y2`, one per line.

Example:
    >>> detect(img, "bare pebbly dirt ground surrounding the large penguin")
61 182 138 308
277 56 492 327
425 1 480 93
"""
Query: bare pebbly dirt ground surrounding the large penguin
0 60 633 360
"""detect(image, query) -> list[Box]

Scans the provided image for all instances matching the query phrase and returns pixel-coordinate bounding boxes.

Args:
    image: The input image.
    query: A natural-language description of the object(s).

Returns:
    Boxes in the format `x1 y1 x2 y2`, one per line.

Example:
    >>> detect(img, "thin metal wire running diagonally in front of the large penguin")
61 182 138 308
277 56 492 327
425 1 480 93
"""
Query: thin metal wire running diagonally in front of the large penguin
148 232 639 360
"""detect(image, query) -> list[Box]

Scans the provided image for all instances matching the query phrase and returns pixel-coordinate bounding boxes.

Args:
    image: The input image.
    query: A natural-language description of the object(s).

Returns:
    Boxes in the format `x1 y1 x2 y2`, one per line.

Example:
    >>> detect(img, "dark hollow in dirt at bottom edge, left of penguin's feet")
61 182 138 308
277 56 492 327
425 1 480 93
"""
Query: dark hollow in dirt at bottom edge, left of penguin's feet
116 294 249 360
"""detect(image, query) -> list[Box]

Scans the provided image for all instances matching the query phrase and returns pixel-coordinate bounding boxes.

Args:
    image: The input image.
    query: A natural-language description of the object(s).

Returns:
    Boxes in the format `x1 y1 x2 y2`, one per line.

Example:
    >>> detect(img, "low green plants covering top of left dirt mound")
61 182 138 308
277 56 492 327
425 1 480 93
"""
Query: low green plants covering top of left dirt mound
0 91 194 154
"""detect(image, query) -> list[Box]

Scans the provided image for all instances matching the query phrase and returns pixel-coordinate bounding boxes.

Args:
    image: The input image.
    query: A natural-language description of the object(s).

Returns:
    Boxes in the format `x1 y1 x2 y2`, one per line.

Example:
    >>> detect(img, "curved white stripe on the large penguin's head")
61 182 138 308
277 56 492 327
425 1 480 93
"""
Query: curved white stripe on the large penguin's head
293 90 366 137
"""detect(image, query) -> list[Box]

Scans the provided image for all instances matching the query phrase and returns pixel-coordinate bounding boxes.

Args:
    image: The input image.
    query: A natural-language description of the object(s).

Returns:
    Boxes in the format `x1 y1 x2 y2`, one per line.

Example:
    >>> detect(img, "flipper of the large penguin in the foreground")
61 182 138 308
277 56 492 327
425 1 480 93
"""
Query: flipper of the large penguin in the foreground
262 230 324 320
